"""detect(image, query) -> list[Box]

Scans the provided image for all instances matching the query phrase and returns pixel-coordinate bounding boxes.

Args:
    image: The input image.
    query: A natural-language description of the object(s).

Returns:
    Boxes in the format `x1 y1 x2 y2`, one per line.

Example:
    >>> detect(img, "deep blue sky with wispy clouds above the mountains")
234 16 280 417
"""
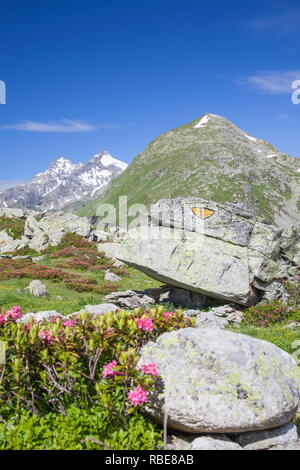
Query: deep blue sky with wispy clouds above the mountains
0 0 300 187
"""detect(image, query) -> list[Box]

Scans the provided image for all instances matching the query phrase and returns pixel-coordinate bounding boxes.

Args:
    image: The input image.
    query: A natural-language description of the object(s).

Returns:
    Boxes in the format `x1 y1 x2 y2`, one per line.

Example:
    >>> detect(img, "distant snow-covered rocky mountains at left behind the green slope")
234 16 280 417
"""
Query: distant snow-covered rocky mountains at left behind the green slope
0 151 127 211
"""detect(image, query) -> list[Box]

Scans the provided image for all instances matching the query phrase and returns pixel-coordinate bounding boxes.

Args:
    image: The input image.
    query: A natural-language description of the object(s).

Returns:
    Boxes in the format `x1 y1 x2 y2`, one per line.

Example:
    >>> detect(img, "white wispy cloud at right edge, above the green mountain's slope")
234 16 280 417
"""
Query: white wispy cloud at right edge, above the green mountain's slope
237 70 300 95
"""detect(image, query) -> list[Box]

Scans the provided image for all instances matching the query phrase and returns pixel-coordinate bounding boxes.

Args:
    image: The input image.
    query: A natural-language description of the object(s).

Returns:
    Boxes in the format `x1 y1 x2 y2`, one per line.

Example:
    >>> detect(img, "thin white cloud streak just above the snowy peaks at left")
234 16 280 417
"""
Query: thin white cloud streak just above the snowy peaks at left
0 119 96 132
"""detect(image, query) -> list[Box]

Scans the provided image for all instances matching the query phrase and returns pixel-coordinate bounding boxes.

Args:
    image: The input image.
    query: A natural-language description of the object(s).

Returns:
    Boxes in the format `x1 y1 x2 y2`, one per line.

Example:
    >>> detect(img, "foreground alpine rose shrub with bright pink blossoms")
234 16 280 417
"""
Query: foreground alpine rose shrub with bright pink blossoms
0 307 193 426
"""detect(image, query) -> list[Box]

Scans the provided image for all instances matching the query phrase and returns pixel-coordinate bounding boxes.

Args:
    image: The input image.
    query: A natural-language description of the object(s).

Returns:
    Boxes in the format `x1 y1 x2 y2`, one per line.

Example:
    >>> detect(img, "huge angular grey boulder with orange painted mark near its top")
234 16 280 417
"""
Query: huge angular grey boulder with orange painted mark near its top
113 198 292 305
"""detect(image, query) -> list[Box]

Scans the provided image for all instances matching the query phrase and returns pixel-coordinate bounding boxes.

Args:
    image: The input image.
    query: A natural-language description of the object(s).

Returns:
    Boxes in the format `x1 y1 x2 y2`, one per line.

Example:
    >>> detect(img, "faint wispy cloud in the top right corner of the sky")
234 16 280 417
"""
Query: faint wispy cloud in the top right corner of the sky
249 9 300 34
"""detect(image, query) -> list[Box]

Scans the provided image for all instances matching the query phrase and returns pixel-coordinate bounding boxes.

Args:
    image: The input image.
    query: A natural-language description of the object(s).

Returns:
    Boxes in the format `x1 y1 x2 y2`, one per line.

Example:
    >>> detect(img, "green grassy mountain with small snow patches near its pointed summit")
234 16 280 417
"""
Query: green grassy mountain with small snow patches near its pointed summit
81 114 300 227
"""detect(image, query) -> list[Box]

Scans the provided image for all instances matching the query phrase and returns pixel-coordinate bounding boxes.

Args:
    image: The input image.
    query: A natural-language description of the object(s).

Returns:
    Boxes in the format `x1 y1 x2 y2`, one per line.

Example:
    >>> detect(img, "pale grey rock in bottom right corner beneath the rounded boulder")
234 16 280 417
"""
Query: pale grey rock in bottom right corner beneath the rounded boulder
237 423 299 450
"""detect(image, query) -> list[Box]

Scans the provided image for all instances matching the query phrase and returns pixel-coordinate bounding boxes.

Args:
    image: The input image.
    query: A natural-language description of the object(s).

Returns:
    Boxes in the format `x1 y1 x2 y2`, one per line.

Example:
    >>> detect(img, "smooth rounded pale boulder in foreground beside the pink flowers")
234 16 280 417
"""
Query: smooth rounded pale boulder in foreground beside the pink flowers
138 328 300 433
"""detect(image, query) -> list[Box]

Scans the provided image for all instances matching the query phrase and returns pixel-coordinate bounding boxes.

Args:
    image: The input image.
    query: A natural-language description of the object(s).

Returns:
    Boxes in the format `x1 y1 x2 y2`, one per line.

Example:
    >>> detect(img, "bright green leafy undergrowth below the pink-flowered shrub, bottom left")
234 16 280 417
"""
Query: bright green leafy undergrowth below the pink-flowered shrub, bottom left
0 406 162 450
